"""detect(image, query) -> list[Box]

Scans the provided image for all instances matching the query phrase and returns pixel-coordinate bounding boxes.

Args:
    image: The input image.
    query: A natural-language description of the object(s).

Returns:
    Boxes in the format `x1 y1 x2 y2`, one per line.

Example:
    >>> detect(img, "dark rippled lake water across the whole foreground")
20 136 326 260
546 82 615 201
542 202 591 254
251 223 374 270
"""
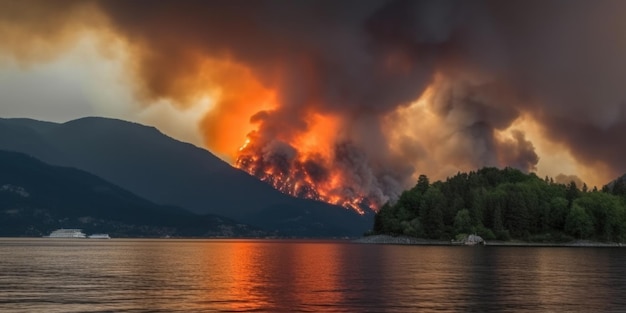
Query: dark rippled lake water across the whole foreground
0 239 626 312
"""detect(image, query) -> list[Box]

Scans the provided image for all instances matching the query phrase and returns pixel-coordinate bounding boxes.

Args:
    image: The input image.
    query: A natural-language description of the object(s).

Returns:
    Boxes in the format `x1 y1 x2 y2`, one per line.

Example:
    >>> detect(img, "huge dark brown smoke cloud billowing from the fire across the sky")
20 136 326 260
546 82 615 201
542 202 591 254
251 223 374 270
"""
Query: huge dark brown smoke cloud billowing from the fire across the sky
4 0 626 204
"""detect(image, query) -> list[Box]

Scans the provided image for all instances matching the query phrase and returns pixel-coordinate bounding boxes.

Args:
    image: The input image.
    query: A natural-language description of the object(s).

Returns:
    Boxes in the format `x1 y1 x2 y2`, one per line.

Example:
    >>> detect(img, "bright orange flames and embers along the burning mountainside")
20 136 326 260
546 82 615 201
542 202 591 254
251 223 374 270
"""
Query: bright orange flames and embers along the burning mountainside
235 114 376 214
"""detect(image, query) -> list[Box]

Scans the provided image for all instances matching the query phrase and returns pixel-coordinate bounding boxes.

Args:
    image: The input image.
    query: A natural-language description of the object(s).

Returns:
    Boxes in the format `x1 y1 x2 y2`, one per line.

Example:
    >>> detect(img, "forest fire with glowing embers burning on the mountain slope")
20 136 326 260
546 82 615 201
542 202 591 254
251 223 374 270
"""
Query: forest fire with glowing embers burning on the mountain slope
235 114 370 214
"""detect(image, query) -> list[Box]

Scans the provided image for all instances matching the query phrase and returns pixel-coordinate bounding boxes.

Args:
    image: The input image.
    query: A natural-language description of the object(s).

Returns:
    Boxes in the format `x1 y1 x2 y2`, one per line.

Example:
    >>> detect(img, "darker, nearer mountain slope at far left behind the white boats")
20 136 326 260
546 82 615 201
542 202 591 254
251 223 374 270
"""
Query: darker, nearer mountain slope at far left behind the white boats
0 150 265 237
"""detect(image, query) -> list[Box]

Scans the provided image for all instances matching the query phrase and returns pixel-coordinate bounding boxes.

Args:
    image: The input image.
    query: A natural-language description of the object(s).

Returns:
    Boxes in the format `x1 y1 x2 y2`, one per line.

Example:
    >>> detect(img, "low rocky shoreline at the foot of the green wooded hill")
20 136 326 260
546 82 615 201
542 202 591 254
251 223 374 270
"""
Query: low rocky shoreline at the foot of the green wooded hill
353 235 626 248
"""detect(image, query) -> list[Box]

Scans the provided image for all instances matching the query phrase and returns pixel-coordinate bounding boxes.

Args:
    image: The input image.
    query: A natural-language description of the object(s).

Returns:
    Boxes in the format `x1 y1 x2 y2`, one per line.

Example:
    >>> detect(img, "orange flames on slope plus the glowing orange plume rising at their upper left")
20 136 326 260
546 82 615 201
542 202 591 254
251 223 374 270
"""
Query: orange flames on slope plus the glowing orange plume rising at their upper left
192 59 380 213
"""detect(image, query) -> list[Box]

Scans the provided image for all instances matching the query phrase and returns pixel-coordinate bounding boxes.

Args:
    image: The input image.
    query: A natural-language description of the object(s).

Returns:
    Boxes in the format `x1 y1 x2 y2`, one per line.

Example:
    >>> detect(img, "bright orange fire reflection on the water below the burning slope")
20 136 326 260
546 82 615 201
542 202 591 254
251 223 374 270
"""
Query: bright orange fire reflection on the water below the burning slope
197 240 345 311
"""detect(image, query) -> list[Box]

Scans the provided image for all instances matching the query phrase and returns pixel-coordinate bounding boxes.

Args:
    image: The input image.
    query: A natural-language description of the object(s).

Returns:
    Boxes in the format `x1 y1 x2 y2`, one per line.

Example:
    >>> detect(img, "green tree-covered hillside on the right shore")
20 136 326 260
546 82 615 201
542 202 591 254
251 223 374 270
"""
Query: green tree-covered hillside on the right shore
373 168 626 242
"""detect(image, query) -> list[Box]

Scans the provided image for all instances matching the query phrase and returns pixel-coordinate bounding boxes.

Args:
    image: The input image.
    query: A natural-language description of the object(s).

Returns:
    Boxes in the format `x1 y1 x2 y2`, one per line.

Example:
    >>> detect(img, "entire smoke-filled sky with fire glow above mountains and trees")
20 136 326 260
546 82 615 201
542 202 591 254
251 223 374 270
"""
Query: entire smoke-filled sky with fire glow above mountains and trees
0 0 626 207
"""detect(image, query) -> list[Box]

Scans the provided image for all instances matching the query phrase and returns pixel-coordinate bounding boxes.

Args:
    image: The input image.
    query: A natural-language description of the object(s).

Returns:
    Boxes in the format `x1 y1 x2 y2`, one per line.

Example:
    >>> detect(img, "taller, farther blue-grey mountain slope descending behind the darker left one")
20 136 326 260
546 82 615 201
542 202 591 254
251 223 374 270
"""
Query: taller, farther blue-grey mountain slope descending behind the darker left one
0 117 372 236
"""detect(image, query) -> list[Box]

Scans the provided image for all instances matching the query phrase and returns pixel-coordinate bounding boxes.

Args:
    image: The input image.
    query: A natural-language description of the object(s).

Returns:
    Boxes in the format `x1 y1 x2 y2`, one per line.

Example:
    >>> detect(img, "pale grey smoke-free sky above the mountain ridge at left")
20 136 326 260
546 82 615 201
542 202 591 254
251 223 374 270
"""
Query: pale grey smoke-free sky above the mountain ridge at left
0 36 203 146
